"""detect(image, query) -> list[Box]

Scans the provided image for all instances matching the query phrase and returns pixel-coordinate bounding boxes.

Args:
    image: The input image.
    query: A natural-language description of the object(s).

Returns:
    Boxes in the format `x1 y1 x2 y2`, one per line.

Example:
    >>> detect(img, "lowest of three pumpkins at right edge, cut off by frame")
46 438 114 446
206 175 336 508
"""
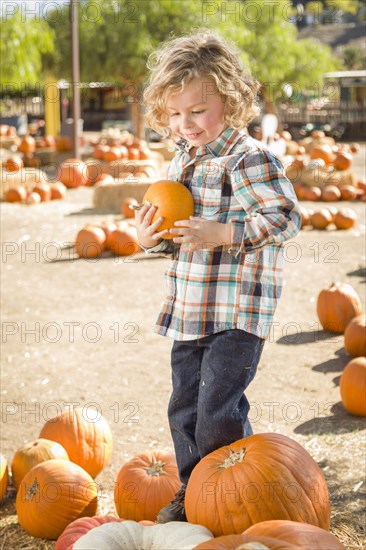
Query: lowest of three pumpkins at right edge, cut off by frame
339 357 366 416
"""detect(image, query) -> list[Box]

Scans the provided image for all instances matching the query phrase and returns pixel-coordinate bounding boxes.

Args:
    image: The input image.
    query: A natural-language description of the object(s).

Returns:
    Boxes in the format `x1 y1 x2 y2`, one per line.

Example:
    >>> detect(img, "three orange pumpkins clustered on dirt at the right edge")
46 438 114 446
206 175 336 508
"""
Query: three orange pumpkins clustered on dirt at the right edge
317 283 366 416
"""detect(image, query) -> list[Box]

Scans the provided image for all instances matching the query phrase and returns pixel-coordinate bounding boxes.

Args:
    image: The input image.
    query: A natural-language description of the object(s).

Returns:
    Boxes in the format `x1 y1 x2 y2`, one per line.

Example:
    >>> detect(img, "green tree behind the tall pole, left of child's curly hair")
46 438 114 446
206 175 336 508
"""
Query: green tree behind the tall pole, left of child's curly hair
47 0 209 82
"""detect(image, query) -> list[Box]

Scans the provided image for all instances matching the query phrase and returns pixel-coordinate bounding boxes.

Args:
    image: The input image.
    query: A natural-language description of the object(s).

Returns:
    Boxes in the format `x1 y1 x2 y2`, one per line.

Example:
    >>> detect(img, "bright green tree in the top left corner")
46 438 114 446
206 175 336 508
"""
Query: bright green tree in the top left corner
0 12 54 87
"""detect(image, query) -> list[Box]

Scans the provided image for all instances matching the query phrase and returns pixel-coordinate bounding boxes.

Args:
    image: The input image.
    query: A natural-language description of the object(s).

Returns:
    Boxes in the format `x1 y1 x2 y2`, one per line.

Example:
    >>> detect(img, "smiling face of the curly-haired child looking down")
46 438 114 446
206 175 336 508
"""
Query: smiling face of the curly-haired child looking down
167 78 226 147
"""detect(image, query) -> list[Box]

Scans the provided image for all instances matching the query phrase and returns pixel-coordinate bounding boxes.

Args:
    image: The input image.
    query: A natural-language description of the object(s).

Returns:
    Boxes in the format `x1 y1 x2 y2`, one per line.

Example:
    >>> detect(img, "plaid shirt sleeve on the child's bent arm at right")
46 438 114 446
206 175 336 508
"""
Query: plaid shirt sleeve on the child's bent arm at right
230 150 301 254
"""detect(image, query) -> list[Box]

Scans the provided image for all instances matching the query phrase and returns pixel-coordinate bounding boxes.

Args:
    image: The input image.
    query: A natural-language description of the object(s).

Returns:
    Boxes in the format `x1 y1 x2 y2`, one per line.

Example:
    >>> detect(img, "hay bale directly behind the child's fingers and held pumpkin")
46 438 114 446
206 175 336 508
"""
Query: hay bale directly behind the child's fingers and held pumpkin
93 179 155 214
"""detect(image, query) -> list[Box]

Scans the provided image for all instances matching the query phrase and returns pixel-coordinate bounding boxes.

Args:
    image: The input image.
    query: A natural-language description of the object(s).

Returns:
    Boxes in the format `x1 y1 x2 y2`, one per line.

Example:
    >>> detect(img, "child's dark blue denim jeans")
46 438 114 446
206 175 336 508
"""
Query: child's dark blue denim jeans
168 329 264 486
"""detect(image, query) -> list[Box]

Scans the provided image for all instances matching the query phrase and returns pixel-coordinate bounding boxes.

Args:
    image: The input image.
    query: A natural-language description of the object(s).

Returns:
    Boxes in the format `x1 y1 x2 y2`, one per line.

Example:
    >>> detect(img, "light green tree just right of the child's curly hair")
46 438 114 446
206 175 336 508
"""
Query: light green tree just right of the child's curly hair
210 0 341 112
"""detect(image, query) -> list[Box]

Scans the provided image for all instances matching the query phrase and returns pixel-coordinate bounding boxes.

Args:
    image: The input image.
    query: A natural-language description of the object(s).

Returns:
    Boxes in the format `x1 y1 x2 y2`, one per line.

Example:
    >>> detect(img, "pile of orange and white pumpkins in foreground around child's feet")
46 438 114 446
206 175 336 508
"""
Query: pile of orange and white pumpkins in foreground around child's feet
1 407 345 550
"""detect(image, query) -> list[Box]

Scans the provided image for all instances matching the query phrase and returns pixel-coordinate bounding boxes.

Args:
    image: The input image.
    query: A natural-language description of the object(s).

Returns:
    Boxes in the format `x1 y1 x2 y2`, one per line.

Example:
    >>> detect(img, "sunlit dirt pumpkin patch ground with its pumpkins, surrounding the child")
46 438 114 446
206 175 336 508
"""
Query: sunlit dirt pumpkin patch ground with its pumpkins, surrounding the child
0 143 366 550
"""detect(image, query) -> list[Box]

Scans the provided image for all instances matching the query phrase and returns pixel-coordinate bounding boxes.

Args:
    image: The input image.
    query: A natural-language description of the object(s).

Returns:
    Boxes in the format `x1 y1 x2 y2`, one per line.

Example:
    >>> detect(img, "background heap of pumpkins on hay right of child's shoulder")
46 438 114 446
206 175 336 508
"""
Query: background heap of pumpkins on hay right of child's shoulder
282 130 366 202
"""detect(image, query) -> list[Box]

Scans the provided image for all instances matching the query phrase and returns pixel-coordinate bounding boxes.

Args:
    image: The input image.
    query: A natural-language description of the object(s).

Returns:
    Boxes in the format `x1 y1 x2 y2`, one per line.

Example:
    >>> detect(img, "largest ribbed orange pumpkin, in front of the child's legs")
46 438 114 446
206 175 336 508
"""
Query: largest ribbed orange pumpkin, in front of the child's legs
185 433 330 536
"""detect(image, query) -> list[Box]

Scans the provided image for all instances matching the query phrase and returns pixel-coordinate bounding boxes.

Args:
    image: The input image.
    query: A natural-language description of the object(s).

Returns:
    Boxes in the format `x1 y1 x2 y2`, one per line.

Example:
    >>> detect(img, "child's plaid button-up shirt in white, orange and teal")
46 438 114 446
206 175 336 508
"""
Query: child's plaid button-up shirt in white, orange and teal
146 128 301 340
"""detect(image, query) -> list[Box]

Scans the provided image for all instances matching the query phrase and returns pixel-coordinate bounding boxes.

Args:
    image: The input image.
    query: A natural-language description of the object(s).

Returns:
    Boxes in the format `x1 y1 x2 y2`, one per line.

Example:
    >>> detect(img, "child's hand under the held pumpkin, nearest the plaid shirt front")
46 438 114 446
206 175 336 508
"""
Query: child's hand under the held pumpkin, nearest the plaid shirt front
169 216 231 250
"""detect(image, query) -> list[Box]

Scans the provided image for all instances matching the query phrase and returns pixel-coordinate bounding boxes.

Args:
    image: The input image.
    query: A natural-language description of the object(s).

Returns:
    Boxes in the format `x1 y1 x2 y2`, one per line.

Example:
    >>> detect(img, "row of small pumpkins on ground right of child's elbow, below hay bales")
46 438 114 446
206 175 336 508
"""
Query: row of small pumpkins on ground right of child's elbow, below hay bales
300 206 357 233
